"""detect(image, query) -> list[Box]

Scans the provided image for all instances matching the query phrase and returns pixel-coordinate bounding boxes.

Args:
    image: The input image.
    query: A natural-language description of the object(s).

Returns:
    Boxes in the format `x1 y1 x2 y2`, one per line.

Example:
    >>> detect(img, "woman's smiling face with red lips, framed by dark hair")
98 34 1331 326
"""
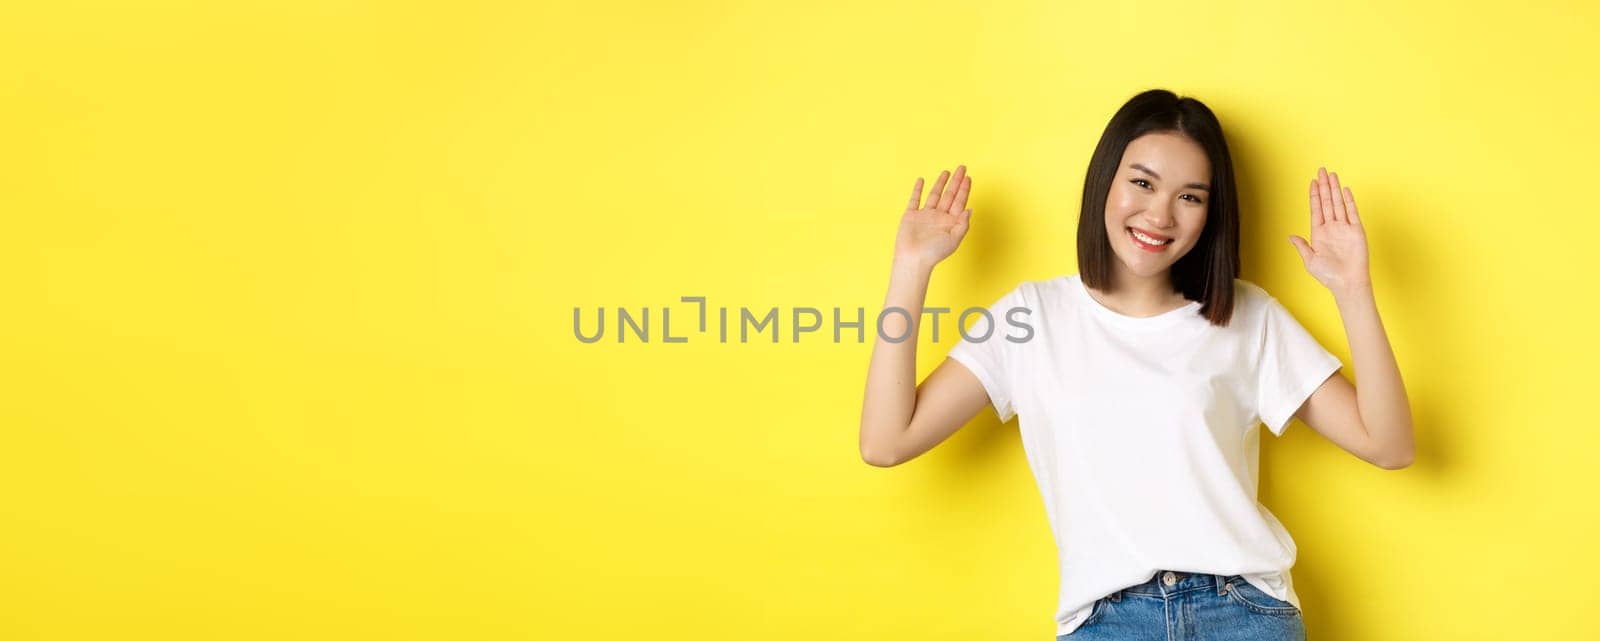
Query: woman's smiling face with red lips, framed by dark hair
1106 131 1211 277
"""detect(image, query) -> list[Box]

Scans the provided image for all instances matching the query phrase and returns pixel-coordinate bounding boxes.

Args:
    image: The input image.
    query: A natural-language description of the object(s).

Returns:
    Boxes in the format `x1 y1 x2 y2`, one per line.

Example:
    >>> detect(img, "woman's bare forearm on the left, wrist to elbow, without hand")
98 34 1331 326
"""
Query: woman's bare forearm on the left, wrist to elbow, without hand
861 261 933 460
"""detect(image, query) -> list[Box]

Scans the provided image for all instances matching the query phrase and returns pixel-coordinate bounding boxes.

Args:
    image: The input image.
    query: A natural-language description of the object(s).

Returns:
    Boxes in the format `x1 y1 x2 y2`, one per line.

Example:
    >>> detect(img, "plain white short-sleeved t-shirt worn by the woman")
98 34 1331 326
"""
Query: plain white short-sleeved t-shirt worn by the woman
949 273 1341 635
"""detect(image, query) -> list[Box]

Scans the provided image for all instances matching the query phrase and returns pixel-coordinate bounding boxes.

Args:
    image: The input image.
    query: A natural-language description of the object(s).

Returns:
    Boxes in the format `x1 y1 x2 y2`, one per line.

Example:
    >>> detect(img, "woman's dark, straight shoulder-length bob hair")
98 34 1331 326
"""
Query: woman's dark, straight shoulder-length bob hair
1078 90 1238 326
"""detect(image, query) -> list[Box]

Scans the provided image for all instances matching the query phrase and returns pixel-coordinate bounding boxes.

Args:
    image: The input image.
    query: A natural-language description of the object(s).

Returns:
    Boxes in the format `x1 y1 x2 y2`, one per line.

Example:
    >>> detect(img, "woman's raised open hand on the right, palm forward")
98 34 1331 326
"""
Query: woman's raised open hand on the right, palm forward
1290 168 1371 294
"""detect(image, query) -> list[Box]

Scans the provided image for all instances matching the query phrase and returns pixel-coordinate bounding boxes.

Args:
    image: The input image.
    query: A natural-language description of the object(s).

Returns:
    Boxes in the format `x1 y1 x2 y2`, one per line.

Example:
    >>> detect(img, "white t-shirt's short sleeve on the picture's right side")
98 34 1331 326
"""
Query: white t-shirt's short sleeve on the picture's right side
1256 297 1342 436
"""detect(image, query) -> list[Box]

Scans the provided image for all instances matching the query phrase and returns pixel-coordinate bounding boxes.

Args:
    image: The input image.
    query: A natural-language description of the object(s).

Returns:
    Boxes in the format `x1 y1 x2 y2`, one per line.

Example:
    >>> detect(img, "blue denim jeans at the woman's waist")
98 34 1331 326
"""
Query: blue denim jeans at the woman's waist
1056 571 1306 641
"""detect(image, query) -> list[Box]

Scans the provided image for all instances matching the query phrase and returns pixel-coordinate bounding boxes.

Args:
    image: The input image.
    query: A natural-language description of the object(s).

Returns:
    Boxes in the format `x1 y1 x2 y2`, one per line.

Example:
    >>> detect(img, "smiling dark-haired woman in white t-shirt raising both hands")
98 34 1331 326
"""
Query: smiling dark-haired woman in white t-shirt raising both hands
861 90 1413 639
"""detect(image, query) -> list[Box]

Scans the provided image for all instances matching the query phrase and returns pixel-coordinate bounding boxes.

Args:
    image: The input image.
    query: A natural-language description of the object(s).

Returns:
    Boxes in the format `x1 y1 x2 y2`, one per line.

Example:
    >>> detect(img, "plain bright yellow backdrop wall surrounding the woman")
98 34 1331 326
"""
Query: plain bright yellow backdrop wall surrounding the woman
0 2 1600 641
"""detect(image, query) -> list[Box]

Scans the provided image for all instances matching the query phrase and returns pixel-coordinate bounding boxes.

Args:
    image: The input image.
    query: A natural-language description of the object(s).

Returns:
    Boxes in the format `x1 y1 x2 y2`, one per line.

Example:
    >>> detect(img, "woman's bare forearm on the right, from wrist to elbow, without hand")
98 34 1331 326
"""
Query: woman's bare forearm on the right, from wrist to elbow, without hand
1334 283 1416 462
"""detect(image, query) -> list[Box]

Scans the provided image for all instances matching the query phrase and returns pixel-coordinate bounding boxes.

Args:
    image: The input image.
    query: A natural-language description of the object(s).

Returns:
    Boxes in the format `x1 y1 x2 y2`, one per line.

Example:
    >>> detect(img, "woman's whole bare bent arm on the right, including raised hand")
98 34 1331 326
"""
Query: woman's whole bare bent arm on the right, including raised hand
1290 169 1416 470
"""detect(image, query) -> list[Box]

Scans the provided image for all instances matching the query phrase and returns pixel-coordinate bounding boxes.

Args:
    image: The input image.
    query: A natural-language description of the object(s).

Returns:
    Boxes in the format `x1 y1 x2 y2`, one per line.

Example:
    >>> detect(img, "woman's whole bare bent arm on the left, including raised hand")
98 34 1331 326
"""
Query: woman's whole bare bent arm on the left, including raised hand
859 166 989 467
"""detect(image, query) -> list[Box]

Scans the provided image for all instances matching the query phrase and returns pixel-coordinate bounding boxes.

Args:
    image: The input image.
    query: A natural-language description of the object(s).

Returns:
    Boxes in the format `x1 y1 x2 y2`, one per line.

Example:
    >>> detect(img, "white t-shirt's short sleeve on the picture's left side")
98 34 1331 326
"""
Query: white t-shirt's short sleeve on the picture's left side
949 283 1034 424
